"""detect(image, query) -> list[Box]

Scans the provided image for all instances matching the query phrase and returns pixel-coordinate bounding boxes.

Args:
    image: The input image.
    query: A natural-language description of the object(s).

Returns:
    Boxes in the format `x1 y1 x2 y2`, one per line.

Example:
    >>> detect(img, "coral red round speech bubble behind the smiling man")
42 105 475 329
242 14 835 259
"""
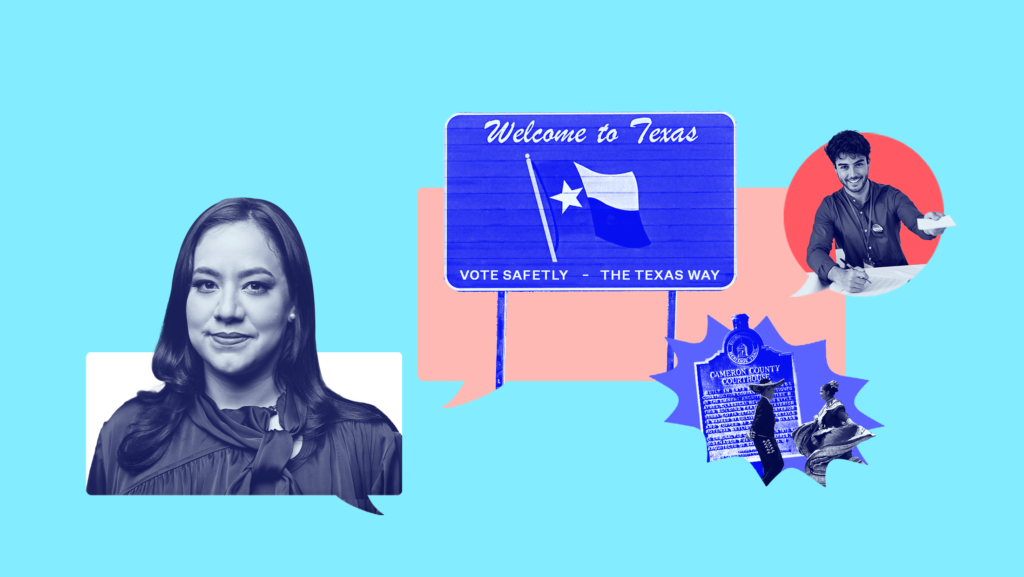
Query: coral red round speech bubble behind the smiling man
782 132 942 273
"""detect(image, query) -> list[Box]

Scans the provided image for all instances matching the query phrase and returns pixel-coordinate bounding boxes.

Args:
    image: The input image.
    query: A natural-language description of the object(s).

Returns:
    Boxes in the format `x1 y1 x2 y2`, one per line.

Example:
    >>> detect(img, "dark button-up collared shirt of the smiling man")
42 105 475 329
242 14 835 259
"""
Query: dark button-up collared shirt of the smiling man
807 180 935 284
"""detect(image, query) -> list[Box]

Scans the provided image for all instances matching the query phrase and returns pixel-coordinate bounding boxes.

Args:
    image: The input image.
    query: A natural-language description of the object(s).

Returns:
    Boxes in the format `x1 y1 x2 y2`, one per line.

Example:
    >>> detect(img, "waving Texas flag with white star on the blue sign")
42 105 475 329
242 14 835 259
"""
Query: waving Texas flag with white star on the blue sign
531 162 651 256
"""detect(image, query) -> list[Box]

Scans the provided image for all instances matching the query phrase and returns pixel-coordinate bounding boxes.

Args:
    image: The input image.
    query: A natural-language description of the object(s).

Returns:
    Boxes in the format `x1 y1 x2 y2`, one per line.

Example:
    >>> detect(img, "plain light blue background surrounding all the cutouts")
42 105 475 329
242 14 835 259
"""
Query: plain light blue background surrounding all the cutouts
0 0 1024 575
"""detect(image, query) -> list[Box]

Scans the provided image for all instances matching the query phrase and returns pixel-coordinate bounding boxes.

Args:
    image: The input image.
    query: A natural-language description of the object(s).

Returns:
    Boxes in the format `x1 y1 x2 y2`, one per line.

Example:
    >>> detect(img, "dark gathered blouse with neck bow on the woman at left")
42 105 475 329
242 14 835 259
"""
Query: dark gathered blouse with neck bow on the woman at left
87 395 401 513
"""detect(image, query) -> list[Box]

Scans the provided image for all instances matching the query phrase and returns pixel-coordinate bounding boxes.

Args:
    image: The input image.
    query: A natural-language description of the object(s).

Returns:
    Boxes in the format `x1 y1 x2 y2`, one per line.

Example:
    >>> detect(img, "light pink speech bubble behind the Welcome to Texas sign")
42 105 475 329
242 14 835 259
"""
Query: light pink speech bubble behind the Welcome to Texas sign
417 189 846 407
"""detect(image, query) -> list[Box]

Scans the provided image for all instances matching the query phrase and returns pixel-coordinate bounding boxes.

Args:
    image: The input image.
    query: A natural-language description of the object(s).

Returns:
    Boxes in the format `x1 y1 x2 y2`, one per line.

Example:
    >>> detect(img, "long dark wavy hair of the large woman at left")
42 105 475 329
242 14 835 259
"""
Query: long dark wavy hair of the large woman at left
118 198 394 470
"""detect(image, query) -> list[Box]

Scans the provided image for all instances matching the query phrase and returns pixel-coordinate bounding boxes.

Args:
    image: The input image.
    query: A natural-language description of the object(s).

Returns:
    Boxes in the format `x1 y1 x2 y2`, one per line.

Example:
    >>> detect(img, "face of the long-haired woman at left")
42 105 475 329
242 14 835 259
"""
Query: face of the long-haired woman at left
185 222 295 376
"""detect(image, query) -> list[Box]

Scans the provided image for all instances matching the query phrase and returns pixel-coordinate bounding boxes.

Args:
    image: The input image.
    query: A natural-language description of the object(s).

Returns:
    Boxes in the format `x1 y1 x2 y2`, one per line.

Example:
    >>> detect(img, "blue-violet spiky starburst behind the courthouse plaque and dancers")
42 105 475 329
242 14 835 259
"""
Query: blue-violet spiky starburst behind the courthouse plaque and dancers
651 317 882 485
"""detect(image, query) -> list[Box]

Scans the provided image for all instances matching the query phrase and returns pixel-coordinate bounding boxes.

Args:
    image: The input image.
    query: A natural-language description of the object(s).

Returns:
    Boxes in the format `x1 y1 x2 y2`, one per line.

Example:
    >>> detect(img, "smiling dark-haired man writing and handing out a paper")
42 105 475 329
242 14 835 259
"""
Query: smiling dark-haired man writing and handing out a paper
807 130 945 292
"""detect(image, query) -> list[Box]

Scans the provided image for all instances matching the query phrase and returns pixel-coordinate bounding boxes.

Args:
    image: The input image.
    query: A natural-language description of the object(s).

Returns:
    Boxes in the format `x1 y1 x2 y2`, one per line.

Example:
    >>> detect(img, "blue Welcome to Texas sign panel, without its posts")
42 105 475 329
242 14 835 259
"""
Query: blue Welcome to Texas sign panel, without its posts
444 113 736 292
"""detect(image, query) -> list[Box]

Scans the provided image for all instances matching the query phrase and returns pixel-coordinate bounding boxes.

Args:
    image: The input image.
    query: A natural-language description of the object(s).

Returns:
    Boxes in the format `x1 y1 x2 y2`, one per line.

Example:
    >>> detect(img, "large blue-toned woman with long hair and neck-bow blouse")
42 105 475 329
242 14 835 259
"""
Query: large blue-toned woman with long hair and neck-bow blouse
87 198 401 512
